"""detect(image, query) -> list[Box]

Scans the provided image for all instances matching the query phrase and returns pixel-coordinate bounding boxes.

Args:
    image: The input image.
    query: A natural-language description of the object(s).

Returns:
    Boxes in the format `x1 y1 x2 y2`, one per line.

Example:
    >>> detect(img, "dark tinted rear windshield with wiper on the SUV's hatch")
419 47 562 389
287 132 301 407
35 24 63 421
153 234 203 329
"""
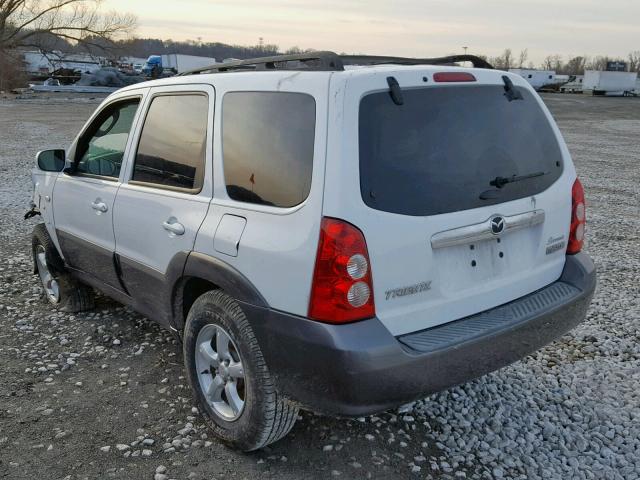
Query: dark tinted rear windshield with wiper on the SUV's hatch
359 85 562 215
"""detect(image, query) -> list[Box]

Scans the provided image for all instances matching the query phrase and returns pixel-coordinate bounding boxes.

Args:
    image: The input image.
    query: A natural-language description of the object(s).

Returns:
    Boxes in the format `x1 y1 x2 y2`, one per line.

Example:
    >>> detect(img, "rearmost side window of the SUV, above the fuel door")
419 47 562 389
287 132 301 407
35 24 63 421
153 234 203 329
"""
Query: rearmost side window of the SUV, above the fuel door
222 92 316 207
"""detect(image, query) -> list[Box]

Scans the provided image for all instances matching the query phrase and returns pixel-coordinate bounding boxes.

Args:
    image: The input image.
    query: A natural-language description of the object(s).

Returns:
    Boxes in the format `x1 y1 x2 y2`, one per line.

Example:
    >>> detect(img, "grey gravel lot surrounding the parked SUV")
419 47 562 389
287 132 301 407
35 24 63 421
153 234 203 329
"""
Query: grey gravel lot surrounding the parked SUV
0 95 640 480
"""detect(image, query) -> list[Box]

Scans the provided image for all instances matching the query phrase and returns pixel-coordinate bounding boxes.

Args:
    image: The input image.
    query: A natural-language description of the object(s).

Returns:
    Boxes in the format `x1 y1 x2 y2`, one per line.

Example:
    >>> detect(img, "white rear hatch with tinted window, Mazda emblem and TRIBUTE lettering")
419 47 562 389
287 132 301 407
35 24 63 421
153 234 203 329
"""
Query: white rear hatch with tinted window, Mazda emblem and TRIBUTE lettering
342 70 575 335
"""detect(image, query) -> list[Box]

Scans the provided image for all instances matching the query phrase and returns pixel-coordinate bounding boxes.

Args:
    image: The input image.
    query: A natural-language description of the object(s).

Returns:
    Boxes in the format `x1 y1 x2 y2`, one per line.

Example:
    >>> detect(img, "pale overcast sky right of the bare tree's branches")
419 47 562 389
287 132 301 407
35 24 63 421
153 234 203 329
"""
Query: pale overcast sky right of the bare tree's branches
105 0 640 65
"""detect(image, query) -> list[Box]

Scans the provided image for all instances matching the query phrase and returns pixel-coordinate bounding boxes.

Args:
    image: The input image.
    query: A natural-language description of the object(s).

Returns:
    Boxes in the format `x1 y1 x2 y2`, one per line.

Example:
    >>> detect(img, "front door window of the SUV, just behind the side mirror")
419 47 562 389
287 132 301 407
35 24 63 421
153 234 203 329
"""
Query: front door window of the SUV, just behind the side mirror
74 99 140 178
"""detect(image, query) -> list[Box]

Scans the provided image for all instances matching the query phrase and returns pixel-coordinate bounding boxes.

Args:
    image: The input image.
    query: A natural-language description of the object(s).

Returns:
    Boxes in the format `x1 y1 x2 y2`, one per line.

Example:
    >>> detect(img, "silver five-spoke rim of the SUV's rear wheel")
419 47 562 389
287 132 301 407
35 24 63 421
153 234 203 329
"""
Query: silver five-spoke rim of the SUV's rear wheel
195 325 246 421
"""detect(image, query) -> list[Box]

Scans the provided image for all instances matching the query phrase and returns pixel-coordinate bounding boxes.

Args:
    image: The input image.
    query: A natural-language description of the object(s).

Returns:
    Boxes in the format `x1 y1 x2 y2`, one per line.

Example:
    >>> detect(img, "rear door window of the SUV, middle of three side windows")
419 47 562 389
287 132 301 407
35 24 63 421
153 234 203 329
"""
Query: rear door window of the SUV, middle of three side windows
131 94 209 193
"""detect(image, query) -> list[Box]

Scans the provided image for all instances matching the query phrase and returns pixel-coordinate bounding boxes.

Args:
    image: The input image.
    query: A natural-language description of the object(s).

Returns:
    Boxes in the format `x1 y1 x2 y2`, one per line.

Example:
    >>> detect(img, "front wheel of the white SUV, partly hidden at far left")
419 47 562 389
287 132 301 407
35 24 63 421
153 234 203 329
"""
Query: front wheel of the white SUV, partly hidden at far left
31 223 94 313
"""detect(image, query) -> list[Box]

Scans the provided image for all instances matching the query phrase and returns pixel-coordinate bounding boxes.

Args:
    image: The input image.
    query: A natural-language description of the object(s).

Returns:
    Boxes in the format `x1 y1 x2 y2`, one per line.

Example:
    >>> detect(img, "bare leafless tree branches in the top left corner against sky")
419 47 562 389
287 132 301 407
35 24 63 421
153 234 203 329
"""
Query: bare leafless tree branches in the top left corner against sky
0 0 136 52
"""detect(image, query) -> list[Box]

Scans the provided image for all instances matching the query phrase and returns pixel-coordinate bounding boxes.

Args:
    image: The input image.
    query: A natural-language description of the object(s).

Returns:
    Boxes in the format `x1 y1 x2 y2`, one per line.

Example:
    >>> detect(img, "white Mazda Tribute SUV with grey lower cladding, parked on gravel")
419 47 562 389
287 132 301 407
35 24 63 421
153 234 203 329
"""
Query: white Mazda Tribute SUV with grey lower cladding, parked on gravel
29 52 596 450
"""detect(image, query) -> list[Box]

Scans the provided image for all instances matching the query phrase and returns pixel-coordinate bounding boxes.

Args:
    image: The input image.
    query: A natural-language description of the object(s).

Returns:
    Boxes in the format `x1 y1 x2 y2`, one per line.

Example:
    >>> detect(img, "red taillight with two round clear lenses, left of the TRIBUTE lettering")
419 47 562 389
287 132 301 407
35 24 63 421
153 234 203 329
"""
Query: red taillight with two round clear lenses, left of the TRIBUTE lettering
309 218 376 323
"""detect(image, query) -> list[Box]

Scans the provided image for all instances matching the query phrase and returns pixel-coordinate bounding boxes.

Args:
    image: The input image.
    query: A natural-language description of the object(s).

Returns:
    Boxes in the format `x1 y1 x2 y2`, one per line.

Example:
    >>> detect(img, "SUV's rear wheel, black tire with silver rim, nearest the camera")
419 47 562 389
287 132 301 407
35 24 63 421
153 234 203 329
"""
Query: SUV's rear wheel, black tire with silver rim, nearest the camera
183 290 298 452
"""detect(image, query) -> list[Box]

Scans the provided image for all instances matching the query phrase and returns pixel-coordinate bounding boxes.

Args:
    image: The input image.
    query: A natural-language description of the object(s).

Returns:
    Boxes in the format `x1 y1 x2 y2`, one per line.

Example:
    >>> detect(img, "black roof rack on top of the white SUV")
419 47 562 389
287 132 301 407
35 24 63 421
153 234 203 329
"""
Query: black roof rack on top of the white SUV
180 51 493 76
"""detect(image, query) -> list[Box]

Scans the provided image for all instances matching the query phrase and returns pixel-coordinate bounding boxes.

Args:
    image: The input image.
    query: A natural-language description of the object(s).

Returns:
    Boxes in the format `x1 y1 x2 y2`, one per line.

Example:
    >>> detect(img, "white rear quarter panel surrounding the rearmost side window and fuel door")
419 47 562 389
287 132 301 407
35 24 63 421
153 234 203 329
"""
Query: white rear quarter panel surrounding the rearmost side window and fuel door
194 72 332 315
